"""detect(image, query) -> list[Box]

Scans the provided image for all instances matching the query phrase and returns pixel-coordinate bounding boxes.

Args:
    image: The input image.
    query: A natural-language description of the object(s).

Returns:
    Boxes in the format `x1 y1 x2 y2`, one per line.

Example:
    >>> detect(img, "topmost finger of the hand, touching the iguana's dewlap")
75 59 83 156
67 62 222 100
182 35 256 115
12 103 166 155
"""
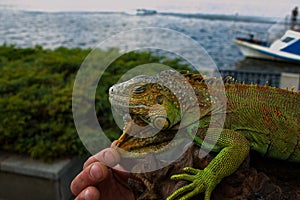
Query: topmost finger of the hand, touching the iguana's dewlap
83 148 120 169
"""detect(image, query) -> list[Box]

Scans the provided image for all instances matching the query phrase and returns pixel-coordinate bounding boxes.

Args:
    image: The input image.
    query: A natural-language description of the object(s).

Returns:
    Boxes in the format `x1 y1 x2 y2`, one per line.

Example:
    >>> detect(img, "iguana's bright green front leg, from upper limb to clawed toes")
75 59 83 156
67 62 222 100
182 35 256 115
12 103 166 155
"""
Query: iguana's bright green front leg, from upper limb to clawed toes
167 129 250 200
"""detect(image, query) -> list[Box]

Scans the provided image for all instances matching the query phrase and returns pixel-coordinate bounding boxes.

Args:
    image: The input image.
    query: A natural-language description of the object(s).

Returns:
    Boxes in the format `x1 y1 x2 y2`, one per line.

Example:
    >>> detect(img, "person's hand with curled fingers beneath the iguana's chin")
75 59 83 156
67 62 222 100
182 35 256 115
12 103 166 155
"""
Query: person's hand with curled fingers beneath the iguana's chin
70 145 134 200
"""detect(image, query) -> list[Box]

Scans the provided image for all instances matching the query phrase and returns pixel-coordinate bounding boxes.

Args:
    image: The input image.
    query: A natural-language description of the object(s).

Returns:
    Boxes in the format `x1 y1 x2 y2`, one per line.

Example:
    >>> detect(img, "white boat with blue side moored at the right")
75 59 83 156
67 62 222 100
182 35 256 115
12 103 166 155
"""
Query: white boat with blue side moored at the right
233 30 300 63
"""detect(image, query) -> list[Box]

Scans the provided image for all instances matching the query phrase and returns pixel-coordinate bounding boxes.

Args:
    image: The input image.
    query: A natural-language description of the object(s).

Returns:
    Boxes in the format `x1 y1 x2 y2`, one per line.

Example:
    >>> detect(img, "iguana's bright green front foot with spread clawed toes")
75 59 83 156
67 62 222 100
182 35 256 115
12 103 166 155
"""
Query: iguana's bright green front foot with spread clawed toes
167 167 220 200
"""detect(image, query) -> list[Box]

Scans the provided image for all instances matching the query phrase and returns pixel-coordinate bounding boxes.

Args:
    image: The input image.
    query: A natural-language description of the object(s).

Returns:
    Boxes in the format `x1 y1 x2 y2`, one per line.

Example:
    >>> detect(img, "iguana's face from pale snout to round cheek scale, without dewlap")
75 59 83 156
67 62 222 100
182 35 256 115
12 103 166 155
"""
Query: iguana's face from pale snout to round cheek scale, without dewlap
109 72 180 130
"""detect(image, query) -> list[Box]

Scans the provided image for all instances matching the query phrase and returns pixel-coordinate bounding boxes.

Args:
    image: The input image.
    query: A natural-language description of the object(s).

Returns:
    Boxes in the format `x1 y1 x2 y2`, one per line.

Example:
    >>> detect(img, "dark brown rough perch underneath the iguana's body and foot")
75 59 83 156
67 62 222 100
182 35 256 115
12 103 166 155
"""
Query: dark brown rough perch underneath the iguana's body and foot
130 145 300 200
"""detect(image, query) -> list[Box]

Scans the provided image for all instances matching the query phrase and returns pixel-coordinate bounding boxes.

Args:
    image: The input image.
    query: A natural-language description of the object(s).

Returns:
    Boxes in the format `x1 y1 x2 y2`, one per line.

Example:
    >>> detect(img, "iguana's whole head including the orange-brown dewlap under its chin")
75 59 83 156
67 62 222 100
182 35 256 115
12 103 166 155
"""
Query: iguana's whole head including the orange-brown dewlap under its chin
109 70 210 153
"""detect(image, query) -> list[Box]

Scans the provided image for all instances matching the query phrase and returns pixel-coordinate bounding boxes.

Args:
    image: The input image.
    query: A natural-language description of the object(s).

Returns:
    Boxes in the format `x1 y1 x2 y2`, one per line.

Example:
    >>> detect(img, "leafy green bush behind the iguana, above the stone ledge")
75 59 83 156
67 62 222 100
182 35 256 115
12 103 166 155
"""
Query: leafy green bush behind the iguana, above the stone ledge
0 45 187 161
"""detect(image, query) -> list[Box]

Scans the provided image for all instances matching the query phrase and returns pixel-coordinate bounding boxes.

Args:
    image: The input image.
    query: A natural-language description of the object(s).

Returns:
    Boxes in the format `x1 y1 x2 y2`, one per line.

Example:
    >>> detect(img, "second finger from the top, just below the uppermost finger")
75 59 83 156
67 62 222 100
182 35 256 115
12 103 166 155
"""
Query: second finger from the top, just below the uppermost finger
70 162 109 195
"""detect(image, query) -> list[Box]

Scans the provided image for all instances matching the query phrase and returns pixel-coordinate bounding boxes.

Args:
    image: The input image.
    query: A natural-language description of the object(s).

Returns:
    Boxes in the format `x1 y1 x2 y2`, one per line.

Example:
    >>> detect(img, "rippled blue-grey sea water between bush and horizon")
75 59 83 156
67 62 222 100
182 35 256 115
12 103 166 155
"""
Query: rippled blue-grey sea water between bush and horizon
0 8 299 71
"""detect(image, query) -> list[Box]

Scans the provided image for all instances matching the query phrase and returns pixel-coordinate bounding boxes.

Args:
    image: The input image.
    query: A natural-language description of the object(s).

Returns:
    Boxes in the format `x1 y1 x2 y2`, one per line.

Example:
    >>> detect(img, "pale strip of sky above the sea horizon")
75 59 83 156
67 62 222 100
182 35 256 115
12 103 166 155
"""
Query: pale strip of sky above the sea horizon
0 0 300 17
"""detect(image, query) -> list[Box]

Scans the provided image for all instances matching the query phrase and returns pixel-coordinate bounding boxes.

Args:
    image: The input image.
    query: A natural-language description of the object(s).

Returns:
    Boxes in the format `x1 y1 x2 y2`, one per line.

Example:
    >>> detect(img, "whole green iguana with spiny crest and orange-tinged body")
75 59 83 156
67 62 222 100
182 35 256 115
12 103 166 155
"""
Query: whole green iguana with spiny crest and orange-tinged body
109 70 300 200
